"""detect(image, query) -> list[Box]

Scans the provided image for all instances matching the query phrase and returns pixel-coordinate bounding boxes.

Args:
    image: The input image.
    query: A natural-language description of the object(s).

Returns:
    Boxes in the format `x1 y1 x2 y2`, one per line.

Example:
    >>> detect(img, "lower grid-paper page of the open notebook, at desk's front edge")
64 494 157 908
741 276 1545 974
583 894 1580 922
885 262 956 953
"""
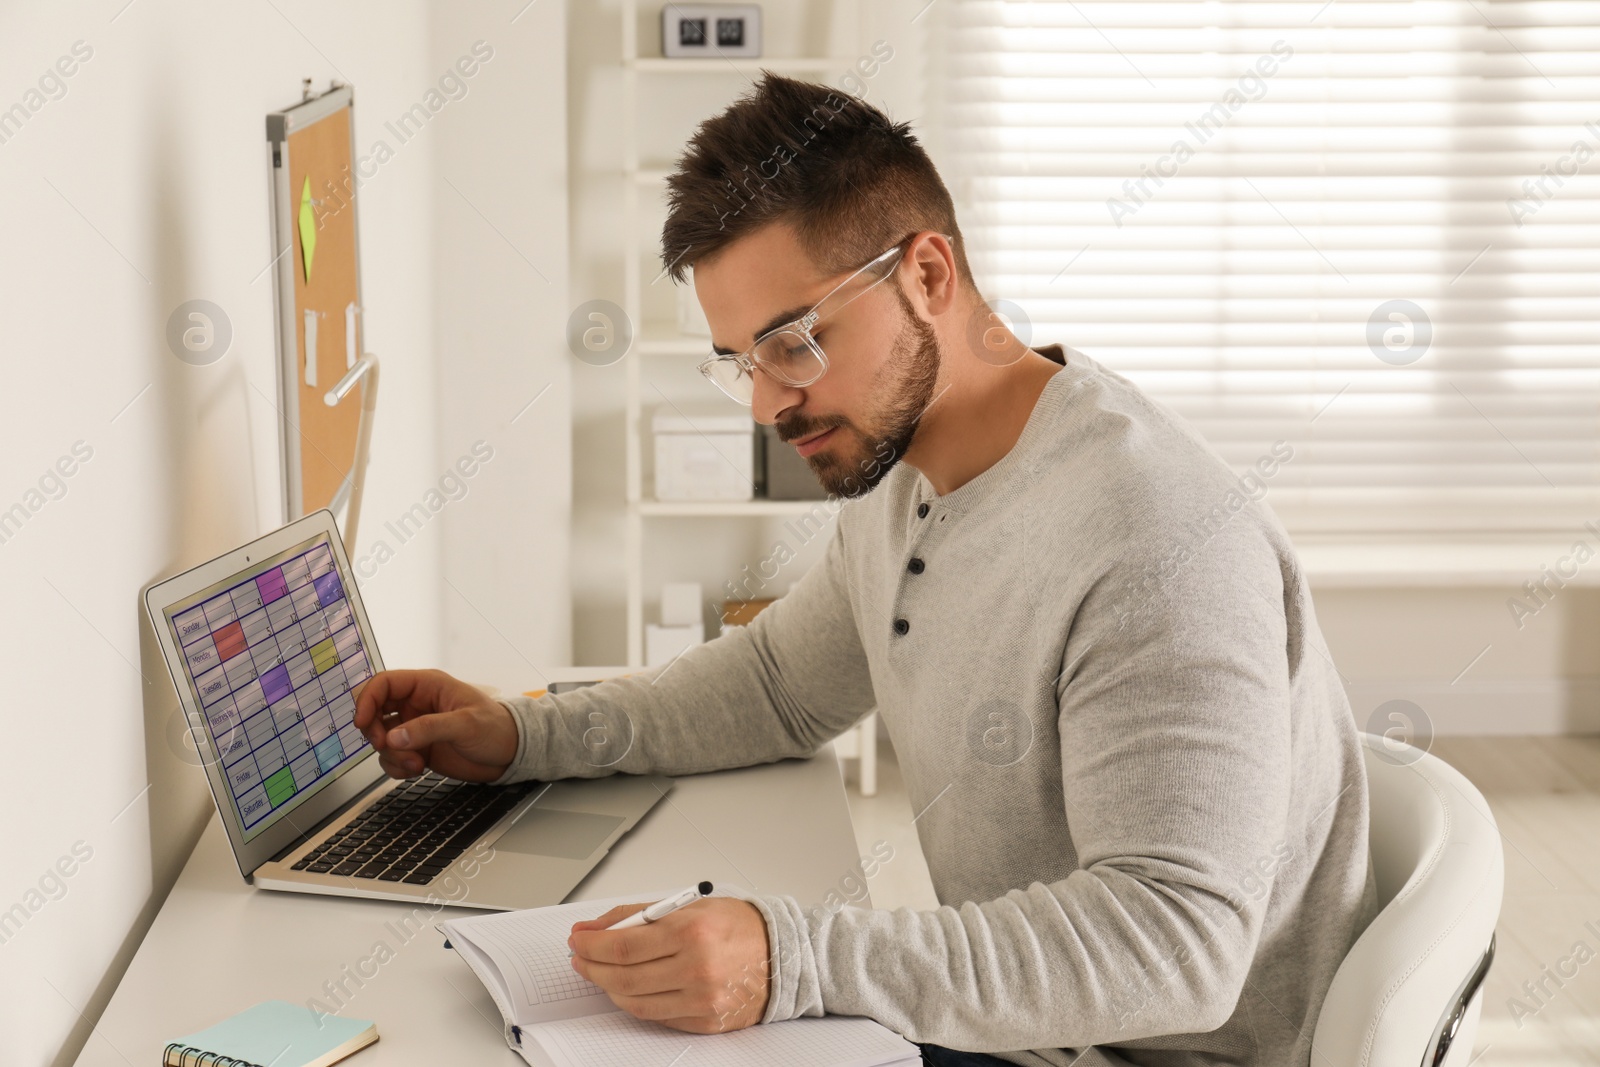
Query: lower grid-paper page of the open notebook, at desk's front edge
523 1011 920 1067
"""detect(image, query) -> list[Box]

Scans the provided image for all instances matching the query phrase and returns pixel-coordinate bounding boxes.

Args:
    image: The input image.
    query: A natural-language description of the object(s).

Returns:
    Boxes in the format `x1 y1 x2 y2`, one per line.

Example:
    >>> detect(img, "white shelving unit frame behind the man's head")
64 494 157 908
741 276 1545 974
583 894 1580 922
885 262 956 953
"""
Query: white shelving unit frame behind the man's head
622 0 877 797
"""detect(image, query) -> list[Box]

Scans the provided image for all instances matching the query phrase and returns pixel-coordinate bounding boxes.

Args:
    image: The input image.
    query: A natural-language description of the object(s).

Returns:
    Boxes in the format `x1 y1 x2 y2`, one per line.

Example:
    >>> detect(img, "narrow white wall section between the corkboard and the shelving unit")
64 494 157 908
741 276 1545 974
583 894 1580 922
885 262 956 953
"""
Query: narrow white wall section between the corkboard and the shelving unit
428 0 576 691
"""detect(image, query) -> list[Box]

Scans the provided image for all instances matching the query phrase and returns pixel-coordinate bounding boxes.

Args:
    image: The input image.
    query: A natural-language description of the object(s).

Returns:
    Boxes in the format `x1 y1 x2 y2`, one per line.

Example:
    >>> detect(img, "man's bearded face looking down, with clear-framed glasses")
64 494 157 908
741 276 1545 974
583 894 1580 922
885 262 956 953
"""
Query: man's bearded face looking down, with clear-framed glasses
694 224 939 496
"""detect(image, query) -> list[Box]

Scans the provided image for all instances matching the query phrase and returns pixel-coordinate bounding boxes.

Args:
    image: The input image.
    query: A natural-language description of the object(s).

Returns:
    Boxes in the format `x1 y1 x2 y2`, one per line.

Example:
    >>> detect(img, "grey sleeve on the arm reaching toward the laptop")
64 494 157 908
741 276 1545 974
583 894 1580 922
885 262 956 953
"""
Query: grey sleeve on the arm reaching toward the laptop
496 523 874 784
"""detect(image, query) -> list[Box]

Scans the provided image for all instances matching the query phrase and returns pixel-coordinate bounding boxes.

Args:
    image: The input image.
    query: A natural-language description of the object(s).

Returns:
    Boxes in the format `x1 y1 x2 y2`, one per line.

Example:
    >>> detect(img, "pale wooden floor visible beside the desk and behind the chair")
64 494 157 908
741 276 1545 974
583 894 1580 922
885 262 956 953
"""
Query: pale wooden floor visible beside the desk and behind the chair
846 737 1600 1067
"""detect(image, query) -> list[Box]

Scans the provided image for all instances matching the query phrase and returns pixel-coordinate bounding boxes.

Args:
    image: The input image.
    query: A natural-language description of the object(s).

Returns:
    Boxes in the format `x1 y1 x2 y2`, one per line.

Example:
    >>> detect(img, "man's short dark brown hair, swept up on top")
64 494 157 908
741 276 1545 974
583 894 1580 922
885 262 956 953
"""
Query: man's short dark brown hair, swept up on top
661 70 976 291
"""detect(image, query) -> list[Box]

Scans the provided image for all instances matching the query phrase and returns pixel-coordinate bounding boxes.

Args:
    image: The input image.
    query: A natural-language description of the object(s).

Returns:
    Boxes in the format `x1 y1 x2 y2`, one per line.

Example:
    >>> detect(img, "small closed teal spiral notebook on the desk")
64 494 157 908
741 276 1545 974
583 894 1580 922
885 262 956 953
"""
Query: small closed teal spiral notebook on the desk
162 1000 378 1067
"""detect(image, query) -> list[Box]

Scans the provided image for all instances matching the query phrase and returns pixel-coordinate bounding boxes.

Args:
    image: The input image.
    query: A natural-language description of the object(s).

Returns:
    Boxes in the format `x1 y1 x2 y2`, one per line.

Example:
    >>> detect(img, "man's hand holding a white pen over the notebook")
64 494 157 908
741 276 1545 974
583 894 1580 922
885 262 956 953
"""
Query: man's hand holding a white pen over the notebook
566 897 771 1033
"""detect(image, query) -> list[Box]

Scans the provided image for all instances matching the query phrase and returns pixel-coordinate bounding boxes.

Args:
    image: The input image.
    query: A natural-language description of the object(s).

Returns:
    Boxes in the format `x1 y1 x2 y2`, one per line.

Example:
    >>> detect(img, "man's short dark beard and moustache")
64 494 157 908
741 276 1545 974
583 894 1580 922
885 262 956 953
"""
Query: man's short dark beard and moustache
776 286 942 498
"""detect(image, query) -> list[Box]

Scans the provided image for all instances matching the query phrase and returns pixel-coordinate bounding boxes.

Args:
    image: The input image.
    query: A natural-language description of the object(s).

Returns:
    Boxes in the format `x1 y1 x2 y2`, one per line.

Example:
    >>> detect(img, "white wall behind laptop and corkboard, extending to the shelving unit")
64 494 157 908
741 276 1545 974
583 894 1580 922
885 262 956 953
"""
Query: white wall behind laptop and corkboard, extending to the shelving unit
0 0 570 1067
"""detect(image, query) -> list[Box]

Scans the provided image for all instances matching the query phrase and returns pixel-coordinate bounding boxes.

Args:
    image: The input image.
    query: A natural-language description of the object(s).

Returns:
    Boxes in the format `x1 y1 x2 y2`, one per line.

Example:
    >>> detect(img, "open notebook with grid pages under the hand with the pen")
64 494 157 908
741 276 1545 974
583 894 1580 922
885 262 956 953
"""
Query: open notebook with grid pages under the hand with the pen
437 886 922 1067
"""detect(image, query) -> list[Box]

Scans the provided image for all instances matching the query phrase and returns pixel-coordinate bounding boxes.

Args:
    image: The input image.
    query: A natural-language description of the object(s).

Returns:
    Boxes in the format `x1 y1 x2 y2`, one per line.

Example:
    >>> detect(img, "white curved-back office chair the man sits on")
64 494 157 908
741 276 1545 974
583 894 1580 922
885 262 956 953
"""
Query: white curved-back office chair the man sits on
1312 734 1506 1067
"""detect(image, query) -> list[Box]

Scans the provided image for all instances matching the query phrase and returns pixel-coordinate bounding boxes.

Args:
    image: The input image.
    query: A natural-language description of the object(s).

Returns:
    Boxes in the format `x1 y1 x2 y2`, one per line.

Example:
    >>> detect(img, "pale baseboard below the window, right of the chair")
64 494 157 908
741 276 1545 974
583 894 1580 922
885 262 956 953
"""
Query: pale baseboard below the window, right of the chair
1346 678 1600 737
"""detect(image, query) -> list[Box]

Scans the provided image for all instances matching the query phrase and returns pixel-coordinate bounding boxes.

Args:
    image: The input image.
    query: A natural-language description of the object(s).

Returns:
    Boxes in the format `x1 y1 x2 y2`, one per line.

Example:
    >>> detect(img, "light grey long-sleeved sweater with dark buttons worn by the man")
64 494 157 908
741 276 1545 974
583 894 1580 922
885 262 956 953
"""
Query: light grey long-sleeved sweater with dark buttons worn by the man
501 346 1374 1067
